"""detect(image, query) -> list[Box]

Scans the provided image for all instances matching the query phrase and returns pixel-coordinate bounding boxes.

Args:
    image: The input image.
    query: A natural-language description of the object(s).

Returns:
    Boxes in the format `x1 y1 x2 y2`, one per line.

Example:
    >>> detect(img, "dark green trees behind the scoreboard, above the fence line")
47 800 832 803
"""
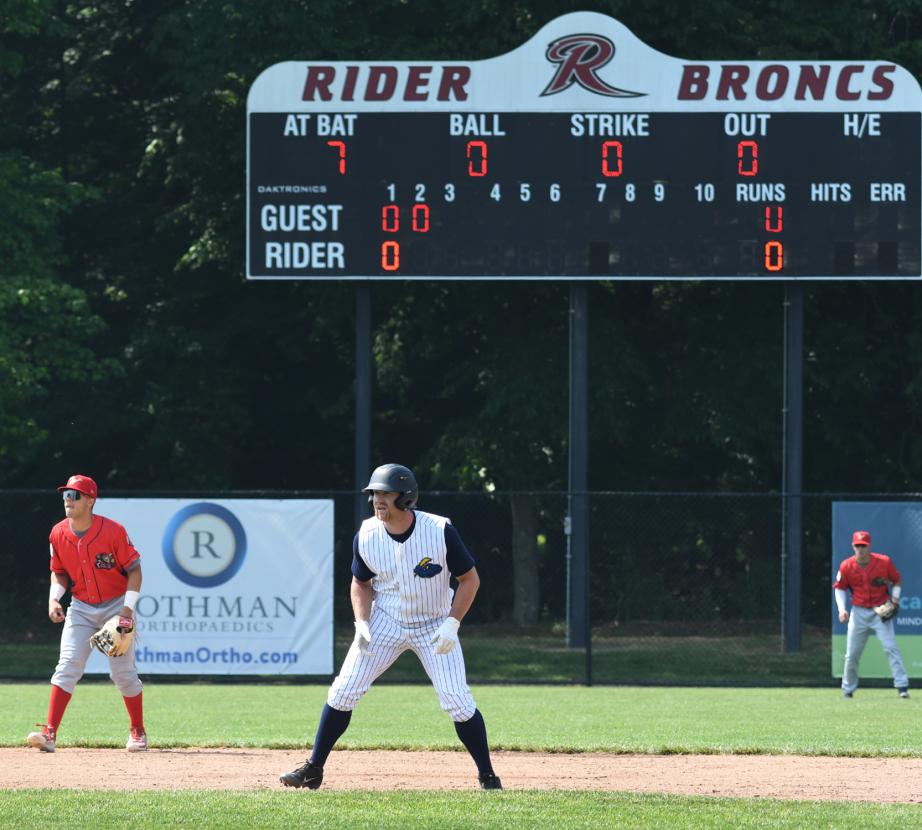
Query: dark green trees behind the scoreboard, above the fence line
0 0 922 500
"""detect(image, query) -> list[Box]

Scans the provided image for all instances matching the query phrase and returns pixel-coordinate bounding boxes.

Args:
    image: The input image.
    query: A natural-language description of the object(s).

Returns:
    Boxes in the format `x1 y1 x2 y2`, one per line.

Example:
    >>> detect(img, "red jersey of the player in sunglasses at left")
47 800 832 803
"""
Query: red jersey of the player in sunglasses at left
48 516 141 605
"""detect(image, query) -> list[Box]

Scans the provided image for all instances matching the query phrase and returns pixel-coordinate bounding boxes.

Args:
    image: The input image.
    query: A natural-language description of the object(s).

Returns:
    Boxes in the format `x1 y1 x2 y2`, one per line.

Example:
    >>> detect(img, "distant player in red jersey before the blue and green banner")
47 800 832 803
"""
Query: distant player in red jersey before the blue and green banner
833 530 909 698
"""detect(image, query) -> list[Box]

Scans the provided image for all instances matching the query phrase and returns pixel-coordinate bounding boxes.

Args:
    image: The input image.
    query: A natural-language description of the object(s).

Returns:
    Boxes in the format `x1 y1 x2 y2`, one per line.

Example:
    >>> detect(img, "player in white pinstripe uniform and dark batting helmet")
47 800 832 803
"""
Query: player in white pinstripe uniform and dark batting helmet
279 464 502 790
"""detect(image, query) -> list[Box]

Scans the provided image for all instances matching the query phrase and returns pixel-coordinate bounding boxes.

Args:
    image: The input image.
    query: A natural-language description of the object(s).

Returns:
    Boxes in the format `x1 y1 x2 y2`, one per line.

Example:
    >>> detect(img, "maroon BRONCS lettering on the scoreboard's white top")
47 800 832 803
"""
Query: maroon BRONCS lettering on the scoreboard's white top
678 63 896 101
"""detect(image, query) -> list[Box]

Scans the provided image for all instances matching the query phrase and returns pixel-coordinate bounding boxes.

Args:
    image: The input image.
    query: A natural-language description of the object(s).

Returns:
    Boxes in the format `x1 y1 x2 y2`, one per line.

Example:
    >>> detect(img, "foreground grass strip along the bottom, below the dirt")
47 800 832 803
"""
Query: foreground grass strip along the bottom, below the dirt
0 790 922 830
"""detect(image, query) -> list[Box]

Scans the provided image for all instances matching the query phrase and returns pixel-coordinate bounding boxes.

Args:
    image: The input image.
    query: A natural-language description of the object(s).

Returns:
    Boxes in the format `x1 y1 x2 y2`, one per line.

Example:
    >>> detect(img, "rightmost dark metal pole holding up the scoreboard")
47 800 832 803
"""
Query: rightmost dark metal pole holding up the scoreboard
781 281 804 653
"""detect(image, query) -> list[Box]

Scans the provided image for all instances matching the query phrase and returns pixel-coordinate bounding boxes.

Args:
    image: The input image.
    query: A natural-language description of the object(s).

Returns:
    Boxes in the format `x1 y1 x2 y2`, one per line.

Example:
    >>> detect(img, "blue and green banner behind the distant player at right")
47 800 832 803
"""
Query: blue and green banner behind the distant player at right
829 501 922 678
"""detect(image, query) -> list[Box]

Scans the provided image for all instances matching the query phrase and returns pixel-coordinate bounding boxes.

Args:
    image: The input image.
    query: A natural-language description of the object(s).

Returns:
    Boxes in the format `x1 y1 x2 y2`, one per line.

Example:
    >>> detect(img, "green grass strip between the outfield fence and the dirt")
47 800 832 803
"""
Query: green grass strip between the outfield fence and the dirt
0 682 922 757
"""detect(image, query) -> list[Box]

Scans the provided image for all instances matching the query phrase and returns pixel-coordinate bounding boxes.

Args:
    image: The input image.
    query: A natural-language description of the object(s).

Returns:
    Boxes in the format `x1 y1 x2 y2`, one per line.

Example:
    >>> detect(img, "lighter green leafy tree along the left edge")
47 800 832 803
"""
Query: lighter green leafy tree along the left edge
0 0 119 482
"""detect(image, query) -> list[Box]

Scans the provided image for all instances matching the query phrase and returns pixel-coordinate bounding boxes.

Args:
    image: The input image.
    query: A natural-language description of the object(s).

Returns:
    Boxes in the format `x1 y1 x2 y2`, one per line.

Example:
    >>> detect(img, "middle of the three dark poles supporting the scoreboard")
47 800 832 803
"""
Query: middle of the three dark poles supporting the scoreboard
566 282 592 686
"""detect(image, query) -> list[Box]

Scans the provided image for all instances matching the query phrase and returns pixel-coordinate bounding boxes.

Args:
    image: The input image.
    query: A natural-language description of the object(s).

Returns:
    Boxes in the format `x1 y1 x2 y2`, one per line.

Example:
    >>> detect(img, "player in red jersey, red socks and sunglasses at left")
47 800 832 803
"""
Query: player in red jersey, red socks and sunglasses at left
26 475 147 752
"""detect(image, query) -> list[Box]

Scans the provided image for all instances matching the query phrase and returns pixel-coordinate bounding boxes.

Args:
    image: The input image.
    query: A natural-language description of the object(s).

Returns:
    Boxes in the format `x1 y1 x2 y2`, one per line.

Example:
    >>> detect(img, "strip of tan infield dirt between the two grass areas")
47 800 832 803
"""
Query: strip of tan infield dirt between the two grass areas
0 747 922 803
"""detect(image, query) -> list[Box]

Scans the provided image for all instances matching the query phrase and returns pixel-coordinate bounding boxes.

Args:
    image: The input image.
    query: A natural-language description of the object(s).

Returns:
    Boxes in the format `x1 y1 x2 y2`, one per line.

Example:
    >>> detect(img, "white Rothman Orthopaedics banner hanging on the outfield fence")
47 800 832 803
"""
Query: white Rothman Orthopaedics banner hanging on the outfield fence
79 499 333 675
